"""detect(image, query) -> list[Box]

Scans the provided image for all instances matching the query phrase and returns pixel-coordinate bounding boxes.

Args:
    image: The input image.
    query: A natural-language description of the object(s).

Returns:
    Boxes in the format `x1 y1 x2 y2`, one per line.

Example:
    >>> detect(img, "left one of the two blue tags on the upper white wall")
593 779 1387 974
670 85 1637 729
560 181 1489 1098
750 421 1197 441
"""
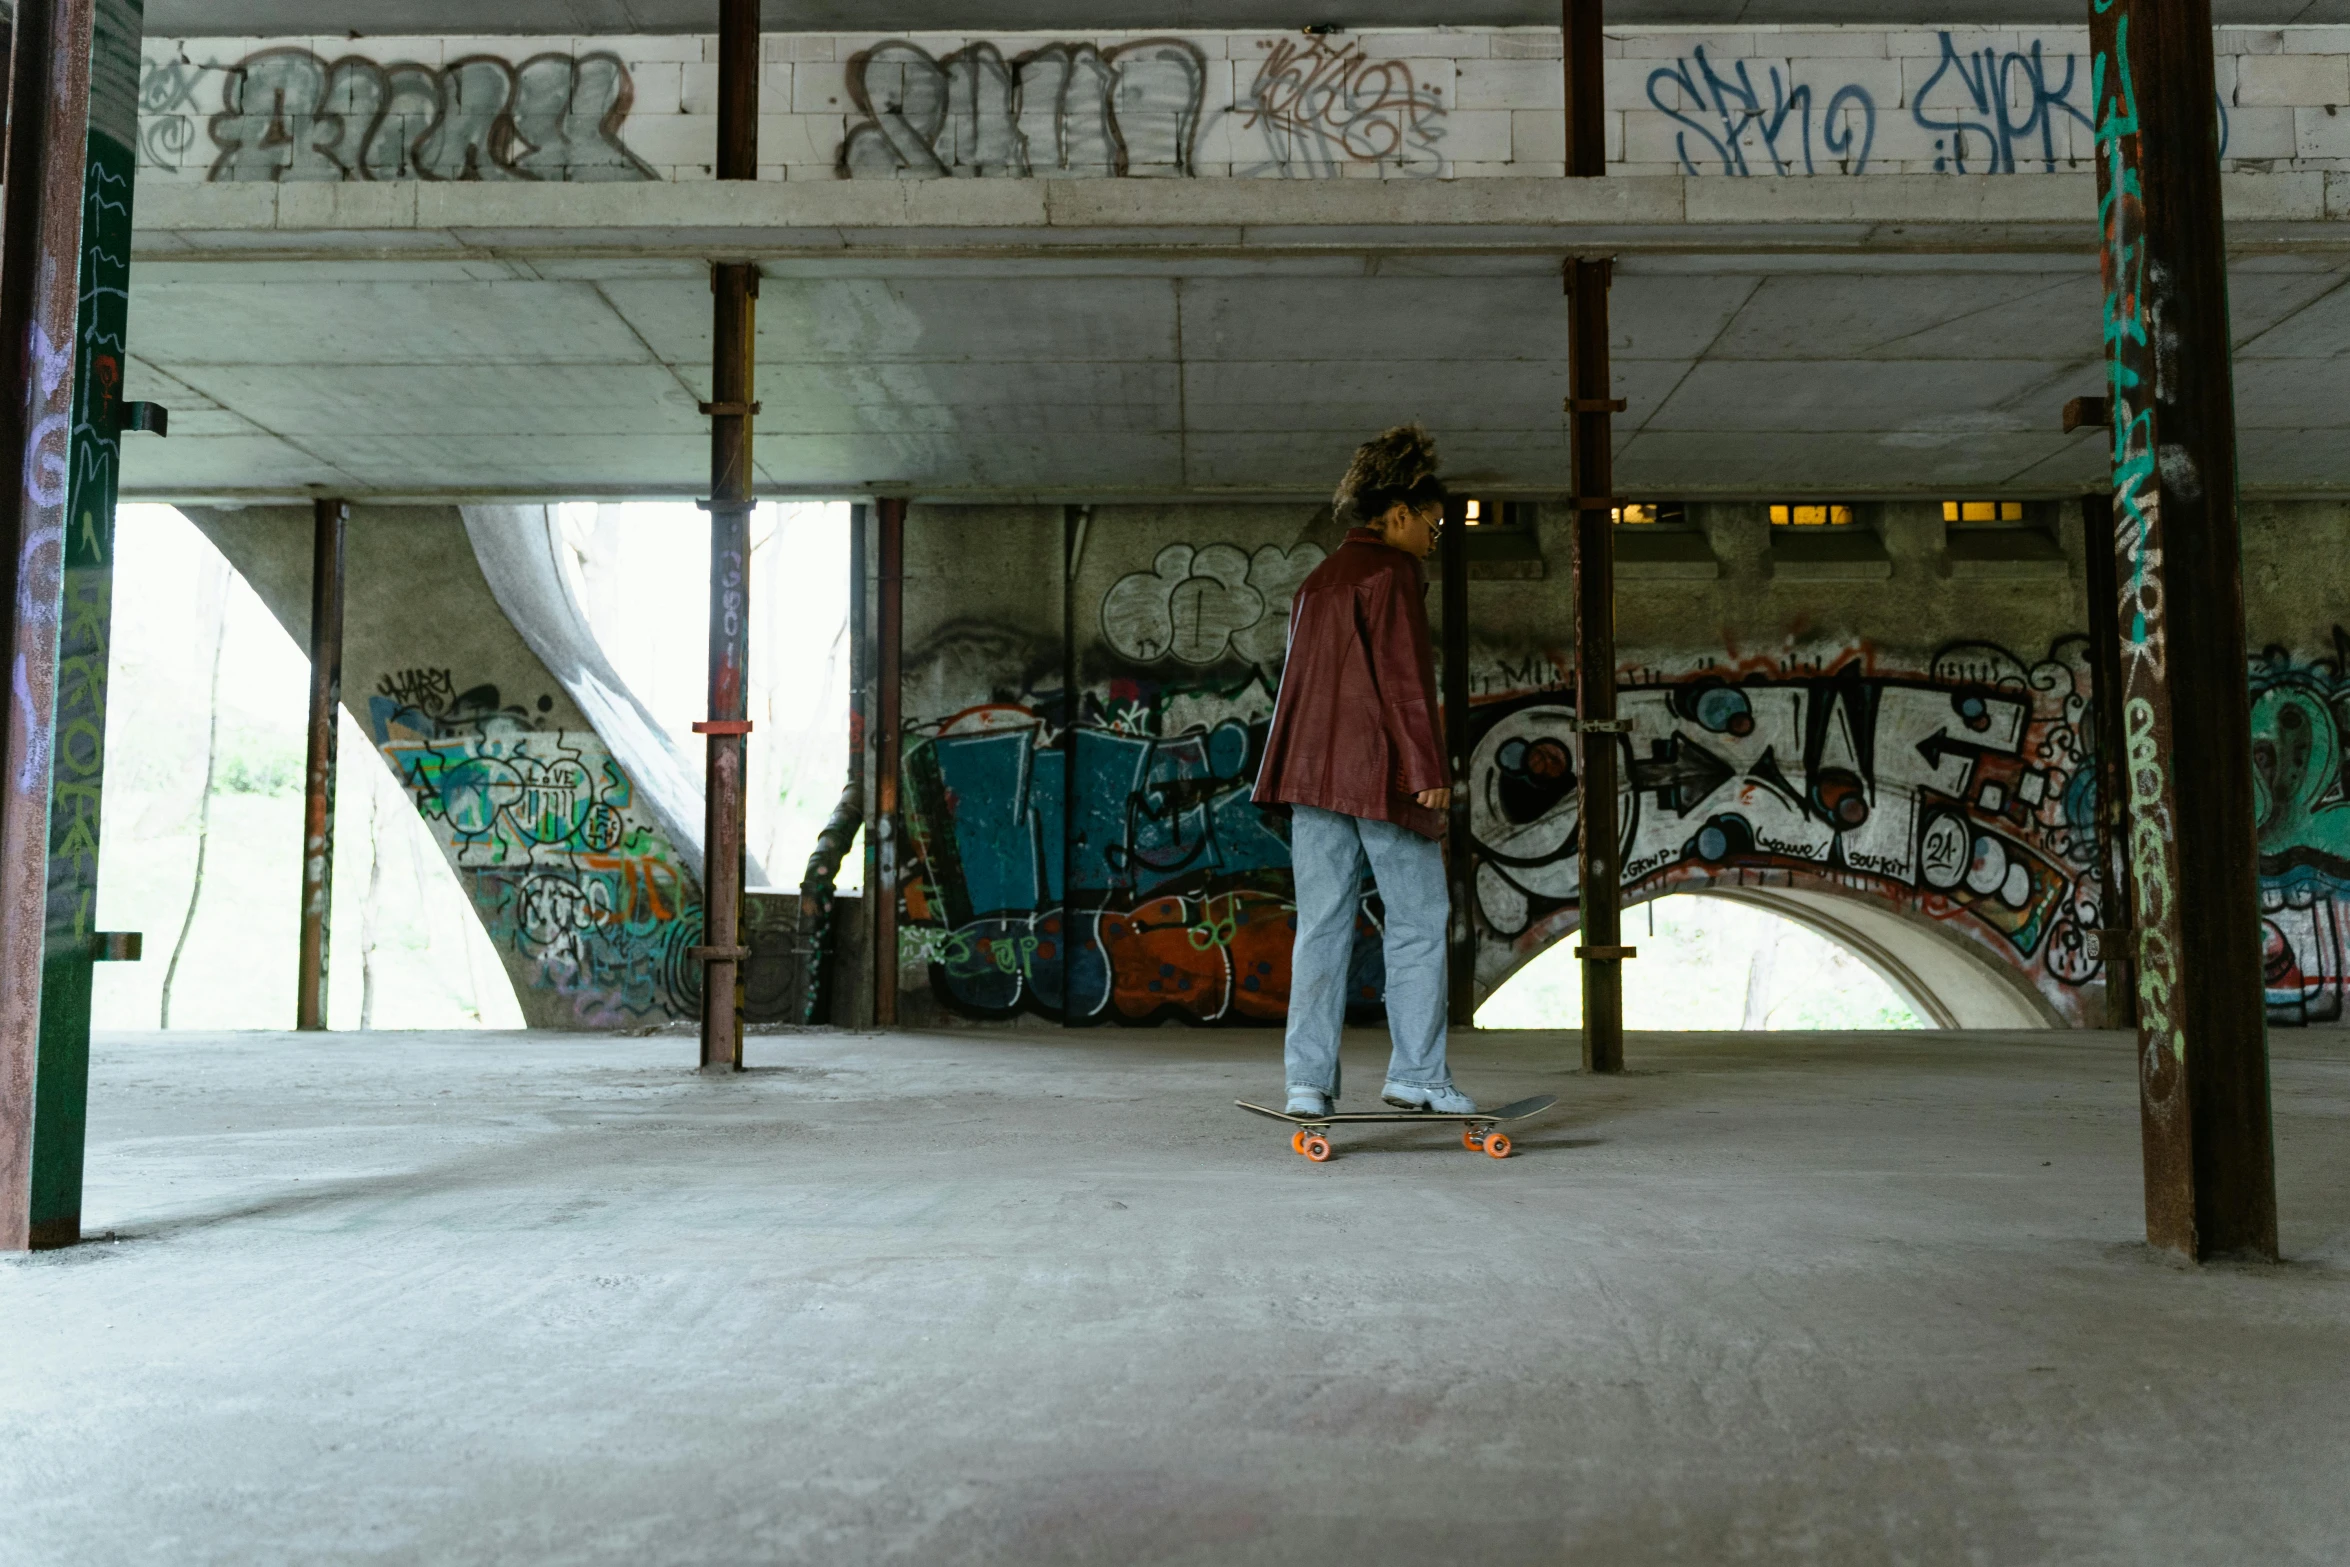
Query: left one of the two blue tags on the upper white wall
1647 46 1879 174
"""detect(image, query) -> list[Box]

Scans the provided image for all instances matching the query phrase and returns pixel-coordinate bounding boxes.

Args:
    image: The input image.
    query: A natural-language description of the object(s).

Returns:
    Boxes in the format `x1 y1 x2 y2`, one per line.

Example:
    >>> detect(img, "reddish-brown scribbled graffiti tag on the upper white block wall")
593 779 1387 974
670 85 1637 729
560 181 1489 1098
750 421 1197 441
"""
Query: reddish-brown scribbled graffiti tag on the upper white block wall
1231 38 1445 179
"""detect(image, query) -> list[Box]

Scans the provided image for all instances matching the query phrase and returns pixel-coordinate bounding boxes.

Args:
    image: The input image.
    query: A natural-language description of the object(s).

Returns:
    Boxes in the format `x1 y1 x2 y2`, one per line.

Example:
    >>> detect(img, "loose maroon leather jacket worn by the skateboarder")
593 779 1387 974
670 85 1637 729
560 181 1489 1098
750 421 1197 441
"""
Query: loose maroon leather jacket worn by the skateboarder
1255 529 1452 839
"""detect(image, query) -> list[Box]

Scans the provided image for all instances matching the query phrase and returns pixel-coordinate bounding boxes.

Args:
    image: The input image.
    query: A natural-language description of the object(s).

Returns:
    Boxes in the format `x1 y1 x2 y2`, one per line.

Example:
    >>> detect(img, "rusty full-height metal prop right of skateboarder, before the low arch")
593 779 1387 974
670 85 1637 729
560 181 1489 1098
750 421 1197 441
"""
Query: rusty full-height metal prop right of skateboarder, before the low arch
1563 0 1638 1071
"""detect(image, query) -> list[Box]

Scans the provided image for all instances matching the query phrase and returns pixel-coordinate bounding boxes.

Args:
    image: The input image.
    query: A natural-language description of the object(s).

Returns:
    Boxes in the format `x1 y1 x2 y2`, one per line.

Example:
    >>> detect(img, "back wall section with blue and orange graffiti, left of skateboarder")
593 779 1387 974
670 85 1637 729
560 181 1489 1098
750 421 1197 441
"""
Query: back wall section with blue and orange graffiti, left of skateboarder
900 507 1382 1024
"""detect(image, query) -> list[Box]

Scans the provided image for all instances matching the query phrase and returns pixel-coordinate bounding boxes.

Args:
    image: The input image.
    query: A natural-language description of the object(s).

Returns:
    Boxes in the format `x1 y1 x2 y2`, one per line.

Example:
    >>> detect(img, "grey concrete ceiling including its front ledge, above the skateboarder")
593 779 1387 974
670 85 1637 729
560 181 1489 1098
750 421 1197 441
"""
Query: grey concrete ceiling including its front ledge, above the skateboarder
122 174 2350 500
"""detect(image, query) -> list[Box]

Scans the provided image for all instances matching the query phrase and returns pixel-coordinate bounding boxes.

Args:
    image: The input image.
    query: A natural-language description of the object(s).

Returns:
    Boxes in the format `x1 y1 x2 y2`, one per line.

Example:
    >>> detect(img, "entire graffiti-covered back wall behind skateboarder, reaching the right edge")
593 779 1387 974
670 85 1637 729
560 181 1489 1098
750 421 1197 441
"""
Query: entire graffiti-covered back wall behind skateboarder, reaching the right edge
878 505 2350 1043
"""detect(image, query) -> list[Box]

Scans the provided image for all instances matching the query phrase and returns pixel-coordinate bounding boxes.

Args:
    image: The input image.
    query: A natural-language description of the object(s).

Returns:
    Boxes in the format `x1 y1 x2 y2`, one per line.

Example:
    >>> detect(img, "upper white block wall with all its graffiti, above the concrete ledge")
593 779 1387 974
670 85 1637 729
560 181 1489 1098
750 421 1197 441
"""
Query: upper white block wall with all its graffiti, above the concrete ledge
139 26 2350 181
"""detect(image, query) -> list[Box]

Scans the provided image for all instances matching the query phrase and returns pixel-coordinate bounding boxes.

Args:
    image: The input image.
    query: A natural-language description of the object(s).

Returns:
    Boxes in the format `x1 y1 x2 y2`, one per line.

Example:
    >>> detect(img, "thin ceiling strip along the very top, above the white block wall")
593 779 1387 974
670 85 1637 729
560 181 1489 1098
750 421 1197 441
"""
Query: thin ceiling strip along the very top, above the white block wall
146 0 2350 38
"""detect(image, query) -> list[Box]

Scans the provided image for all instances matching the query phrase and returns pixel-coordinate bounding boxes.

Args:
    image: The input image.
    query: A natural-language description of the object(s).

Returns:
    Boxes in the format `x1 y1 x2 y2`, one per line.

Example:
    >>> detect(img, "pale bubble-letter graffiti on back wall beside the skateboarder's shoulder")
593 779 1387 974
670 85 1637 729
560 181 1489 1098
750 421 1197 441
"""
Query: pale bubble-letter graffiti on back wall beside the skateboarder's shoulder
1102 545 1323 667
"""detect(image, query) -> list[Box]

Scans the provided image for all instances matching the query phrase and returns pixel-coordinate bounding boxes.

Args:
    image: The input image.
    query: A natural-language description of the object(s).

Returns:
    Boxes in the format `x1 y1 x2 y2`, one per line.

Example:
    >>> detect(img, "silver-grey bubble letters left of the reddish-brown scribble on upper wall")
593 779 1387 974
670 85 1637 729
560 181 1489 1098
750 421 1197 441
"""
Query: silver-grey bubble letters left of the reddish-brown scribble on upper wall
839 38 1208 179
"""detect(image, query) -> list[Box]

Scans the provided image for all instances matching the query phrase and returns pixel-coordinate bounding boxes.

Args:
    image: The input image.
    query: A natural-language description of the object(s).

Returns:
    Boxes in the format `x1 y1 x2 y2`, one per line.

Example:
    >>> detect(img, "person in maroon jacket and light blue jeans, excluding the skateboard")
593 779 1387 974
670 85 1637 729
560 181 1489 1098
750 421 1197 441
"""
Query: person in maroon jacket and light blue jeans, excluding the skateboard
1255 425 1476 1116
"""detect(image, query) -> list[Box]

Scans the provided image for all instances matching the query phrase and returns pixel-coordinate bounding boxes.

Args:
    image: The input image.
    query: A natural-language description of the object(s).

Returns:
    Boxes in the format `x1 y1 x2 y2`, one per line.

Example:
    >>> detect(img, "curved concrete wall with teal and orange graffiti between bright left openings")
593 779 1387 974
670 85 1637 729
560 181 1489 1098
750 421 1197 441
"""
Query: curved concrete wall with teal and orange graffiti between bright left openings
186 505 703 1029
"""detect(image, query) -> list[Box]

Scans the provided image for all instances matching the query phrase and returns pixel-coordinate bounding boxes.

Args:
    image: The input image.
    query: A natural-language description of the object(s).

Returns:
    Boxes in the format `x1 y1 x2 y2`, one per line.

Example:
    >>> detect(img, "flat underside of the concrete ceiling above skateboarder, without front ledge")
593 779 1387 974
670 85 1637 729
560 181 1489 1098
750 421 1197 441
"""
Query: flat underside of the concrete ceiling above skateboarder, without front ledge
125 256 2350 500
